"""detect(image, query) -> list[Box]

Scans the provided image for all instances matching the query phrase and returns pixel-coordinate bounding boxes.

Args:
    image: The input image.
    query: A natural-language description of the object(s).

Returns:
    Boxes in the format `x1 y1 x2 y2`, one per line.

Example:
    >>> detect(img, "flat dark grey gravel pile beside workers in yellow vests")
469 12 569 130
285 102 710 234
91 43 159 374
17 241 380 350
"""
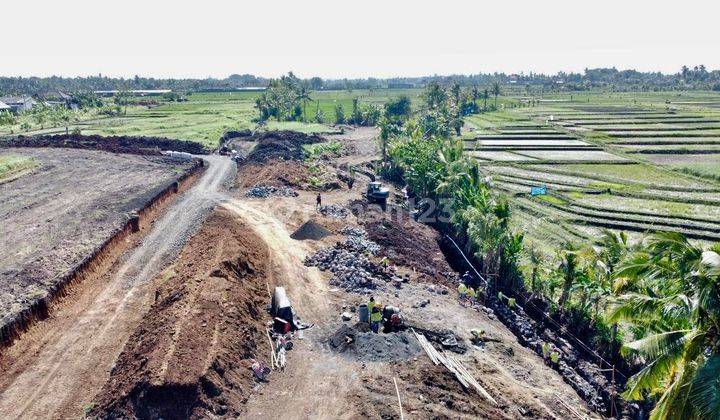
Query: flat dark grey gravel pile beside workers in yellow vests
328 322 422 362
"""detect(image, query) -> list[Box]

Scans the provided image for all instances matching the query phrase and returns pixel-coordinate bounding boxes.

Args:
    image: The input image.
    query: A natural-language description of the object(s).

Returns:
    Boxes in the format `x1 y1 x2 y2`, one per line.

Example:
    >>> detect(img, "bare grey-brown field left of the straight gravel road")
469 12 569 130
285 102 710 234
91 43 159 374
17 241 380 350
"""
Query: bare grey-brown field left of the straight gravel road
0 148 194 334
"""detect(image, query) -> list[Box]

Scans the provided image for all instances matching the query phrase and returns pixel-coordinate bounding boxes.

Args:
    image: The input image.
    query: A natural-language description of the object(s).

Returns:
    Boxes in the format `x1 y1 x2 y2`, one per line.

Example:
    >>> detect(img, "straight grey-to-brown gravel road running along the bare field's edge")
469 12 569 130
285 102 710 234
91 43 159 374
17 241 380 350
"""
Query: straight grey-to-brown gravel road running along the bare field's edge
0 156 235 419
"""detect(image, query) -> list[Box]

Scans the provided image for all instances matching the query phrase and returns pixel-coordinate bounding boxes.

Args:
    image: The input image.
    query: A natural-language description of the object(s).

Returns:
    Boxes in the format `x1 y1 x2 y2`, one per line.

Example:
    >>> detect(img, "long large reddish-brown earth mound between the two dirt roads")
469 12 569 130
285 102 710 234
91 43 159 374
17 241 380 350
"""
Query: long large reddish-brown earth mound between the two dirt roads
90 210 269 418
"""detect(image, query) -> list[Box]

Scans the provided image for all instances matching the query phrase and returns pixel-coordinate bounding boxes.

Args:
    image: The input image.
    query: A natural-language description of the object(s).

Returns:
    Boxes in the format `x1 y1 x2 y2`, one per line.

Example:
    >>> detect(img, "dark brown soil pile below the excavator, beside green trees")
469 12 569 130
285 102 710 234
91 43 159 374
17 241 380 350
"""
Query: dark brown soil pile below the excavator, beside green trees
351 203 452 284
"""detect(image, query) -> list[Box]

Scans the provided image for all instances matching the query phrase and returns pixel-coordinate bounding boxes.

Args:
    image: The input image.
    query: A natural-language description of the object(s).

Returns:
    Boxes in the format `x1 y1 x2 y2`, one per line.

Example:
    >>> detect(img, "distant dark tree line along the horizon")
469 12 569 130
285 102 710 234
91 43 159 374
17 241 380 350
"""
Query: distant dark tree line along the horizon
0 65 720 95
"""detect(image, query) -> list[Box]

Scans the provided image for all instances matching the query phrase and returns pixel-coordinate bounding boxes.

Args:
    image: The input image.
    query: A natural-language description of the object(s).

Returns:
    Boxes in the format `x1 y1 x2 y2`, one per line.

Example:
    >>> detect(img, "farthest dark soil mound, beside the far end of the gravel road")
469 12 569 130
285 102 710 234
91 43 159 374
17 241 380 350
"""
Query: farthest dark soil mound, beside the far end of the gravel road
246 131 324 163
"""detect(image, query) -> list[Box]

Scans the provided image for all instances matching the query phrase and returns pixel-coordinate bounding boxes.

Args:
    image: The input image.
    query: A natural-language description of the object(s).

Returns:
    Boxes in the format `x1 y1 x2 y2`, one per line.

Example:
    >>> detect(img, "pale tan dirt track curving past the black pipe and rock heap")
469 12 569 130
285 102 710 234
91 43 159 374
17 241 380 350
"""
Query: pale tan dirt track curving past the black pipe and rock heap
223 200 360 419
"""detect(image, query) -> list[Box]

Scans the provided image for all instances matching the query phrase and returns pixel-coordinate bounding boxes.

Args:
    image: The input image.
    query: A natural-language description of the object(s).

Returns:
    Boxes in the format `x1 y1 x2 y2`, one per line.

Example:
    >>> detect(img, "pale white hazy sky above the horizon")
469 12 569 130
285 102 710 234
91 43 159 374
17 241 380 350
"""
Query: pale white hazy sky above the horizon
5 0 720 78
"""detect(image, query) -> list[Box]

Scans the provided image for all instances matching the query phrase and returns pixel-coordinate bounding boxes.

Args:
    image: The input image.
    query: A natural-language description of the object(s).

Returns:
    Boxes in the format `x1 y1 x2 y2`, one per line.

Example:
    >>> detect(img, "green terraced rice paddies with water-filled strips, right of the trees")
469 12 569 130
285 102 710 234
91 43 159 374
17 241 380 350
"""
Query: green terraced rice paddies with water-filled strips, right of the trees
465 101 720 253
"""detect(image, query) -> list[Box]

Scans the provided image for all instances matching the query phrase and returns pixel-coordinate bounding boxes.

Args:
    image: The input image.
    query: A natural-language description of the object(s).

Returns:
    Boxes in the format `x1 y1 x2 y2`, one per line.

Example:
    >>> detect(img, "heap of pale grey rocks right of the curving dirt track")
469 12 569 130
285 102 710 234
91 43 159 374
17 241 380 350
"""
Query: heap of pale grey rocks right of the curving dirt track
305 226 393 291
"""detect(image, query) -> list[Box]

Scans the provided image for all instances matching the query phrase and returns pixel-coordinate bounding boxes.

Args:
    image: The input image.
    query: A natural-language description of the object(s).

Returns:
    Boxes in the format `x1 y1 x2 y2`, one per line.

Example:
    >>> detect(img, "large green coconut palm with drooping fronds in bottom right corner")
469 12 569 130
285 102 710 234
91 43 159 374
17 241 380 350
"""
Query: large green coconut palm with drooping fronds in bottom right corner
607 233 720 419
